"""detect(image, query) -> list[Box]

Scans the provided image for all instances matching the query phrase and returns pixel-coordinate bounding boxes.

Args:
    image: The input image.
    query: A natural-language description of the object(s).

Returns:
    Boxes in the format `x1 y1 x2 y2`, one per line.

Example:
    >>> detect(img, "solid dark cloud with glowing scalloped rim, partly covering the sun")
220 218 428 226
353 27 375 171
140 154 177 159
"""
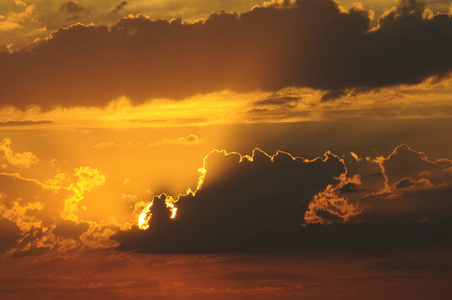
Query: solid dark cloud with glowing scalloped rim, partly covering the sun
114 150 345 252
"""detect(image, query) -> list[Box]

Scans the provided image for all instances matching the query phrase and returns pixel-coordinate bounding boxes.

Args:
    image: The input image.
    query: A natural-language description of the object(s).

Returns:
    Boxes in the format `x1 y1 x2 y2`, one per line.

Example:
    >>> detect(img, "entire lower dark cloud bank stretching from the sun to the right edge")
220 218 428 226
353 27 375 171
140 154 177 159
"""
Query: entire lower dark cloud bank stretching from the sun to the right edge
113 145 452 253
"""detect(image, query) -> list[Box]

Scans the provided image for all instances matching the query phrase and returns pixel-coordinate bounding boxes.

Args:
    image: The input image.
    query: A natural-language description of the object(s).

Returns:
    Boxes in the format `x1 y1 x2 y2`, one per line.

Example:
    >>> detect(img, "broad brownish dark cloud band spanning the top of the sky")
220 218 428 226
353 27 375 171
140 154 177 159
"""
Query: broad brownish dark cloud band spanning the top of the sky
0 0 452 108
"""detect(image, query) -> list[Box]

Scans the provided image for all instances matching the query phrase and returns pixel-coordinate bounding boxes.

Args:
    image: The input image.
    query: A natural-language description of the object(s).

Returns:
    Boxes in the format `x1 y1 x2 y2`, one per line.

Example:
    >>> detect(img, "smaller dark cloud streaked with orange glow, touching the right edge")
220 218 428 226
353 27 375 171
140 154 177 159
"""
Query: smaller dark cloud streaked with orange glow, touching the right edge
314 145 452 226
